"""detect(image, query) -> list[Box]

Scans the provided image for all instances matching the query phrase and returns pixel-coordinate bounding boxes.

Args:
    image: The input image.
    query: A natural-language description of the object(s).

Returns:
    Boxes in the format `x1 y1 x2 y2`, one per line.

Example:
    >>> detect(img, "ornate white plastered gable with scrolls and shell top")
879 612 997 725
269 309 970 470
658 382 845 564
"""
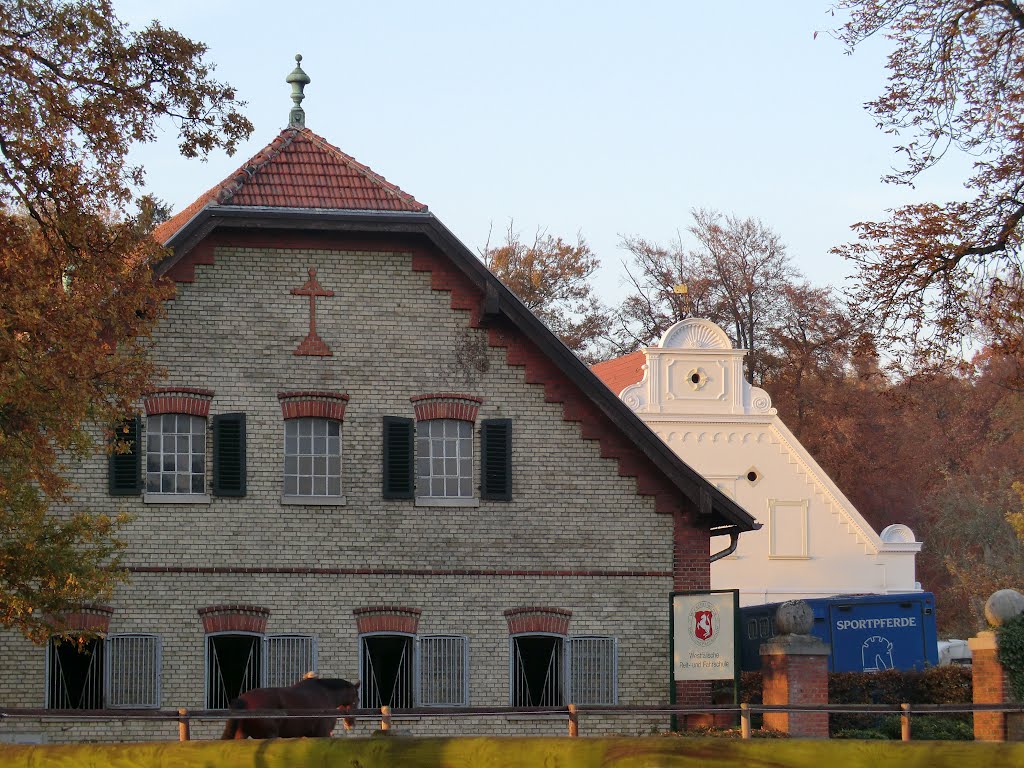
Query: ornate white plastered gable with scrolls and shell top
620 318 921 605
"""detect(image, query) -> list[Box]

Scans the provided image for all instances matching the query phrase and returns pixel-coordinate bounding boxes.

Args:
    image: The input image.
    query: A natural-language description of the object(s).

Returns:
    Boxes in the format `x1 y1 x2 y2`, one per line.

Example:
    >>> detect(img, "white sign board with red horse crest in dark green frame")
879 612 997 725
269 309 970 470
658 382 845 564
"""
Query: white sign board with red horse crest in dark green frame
671 590 739 681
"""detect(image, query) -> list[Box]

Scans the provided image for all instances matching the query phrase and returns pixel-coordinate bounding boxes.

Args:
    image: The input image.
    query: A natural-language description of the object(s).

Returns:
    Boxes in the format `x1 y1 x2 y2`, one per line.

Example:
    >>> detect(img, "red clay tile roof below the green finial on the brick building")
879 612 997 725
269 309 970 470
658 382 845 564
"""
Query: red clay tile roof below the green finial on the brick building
154 128 427 243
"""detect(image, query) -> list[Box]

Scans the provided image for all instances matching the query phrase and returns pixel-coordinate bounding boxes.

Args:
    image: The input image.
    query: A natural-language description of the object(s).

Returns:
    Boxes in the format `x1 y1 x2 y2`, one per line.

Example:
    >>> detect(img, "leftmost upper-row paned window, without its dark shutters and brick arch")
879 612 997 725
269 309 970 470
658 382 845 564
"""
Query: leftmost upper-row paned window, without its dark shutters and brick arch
145 414 206 494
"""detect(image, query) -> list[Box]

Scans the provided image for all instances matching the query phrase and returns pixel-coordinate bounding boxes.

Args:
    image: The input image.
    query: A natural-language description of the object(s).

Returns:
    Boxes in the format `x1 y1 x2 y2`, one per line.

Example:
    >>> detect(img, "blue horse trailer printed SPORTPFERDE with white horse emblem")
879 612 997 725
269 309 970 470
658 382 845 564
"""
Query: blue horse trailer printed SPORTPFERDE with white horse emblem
739 592 939 672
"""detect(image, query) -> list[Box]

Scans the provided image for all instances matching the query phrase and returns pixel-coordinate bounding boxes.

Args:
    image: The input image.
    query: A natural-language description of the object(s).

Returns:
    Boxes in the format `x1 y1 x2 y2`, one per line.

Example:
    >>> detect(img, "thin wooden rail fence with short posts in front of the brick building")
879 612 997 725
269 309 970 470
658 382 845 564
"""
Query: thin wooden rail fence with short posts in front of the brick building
0 703 1024 741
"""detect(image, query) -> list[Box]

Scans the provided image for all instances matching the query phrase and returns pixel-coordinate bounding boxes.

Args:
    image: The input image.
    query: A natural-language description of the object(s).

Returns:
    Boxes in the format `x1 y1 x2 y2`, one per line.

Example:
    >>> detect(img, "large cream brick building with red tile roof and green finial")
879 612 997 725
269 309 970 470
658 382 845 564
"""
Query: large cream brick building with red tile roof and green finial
0 69 756 740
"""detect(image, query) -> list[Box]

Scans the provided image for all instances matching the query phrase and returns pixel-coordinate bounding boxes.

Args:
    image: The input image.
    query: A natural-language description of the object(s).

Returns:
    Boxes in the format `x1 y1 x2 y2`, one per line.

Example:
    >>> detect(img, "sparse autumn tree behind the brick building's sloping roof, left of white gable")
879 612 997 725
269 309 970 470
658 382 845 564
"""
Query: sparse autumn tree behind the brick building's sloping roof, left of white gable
481 224 609 364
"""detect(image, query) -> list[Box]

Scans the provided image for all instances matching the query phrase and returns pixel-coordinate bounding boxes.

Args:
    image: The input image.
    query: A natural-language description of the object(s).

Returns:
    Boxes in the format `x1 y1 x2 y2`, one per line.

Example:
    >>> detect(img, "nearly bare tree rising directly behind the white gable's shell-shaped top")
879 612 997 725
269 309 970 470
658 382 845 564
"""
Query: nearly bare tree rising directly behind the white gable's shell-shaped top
618 209 798 383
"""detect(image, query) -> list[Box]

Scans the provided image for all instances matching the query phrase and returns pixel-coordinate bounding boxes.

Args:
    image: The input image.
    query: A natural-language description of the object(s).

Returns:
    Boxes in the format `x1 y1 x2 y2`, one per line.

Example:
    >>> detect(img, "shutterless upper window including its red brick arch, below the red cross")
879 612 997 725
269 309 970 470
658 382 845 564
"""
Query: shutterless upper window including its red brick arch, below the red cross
278 391 348 504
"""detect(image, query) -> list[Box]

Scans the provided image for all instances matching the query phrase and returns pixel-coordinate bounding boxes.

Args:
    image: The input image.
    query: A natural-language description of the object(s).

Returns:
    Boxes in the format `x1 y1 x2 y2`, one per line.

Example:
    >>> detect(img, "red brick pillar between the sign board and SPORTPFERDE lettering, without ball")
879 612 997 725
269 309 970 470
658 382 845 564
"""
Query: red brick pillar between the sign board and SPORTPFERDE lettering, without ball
761 635 829 738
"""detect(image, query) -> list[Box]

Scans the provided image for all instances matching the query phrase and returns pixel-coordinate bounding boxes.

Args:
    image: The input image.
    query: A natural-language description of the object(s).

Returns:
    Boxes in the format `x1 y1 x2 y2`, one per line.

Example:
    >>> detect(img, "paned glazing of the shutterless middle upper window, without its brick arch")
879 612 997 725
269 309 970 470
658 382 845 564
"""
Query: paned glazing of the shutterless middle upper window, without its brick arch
284 417 343 503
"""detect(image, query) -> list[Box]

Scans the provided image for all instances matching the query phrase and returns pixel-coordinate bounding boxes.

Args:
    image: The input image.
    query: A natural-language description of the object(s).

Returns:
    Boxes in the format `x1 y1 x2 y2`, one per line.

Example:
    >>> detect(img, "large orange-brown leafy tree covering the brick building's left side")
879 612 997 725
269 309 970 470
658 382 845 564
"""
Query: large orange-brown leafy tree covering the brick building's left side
0 0 252 639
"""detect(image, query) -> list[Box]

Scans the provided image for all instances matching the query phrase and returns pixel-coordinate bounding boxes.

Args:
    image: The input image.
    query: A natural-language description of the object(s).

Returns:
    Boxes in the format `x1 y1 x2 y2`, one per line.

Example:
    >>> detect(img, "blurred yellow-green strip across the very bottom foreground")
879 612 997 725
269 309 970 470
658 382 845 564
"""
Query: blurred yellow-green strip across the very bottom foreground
0 736 1024 768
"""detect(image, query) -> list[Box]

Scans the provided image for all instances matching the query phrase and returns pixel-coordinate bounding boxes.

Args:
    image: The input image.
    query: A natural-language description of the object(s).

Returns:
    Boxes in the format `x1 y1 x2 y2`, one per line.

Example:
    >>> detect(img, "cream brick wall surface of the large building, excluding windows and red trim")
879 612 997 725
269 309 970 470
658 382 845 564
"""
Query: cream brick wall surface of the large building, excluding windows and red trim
0 243 688 740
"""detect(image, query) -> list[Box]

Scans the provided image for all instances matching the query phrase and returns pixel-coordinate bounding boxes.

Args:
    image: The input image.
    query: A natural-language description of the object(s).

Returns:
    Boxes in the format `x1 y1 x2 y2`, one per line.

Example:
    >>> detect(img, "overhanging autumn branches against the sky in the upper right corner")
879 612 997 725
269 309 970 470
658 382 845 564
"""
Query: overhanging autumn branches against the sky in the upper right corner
836 0 1024 353
